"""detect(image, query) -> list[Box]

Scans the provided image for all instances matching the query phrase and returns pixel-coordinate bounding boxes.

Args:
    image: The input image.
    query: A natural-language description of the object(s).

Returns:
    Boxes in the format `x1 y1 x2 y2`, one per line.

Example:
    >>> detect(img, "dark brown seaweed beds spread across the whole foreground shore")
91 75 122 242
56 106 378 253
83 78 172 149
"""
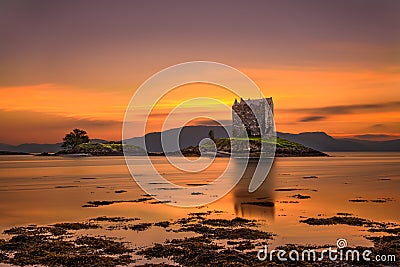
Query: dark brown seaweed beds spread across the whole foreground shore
0 211 400 266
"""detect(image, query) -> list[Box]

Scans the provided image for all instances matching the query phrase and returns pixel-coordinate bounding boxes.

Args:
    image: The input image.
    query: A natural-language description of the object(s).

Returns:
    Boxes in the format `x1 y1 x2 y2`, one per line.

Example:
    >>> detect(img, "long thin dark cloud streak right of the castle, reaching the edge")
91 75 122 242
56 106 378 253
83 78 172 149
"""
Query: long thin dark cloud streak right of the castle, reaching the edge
285 101 400 117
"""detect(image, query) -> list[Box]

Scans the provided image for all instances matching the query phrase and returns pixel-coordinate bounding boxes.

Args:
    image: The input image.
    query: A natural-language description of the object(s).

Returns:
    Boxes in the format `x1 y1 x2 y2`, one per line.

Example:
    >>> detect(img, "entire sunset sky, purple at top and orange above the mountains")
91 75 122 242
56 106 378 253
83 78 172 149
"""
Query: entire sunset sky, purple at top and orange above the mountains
0 0 400 144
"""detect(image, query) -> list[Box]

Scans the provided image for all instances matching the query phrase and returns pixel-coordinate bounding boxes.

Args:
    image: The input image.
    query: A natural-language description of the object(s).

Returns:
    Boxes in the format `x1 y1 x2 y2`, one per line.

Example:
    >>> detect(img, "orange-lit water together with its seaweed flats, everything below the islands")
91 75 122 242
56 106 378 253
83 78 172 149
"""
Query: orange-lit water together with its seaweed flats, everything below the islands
0 153 400 266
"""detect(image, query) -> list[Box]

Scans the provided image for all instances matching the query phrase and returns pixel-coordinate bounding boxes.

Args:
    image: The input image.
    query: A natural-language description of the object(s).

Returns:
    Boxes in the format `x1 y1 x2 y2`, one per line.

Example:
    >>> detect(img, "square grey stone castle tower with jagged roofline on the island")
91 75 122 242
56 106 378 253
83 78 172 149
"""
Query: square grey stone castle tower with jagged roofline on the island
232 97 274 137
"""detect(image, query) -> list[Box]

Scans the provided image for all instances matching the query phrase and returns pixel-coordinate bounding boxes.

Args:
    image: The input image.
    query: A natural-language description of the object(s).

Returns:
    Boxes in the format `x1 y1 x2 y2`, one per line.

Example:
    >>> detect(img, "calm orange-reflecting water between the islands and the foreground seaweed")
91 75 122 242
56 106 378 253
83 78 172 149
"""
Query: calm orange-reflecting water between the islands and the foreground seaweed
0 153 400 250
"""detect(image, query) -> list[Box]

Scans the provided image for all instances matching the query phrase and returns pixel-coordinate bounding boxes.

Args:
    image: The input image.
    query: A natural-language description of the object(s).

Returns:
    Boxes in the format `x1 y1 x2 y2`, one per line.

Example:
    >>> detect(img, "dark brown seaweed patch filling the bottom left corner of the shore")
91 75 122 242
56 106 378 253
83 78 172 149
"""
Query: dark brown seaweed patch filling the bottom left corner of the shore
0 226 134 267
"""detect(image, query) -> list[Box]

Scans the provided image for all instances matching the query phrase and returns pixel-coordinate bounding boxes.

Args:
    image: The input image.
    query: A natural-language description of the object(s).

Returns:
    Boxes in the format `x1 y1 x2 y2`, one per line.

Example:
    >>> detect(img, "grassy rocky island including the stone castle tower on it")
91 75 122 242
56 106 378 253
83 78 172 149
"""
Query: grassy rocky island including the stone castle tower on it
181 97 328 158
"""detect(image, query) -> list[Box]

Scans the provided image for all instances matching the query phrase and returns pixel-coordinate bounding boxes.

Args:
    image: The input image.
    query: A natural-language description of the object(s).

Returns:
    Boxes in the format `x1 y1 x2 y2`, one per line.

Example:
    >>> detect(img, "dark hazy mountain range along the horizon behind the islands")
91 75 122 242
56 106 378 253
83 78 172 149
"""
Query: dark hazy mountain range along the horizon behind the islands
0 126 400 153
